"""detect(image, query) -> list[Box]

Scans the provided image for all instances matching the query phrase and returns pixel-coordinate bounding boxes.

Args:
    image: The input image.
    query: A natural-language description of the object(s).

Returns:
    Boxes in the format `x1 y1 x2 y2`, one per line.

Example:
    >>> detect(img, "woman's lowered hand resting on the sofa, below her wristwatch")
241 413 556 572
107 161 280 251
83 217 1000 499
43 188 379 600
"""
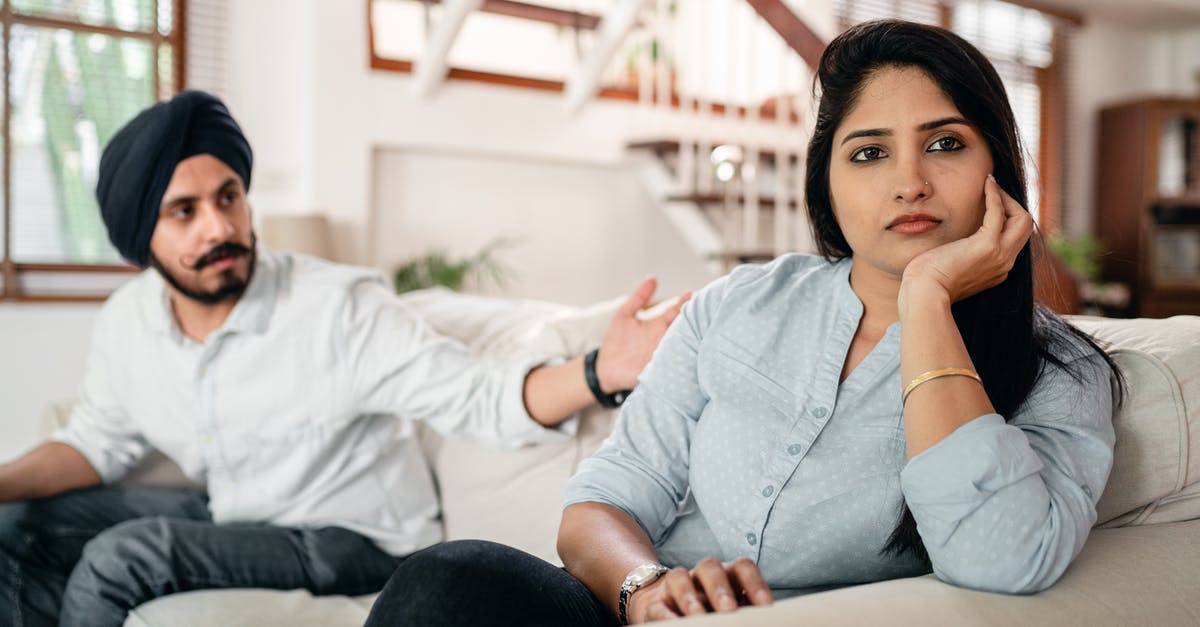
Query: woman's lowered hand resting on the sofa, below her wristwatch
626 557 773 625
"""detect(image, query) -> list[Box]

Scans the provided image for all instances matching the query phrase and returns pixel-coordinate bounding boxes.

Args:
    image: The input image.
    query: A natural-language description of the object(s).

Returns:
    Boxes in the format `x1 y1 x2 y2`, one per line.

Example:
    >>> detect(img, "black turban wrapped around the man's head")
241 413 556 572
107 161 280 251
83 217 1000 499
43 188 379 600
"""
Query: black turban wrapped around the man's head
96 91 254 268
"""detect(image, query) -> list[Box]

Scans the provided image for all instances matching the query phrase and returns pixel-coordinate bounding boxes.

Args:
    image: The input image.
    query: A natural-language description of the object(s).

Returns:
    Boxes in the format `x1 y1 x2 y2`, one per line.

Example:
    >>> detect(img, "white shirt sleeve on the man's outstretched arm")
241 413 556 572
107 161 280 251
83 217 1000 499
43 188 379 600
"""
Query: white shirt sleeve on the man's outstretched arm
340 281 575 447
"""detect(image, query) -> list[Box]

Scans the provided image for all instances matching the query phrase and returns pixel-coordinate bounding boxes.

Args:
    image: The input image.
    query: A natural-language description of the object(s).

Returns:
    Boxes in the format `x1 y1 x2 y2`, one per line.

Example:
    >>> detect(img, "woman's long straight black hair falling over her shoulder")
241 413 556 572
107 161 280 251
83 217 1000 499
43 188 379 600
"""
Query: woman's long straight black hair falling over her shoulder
804 20 1121 567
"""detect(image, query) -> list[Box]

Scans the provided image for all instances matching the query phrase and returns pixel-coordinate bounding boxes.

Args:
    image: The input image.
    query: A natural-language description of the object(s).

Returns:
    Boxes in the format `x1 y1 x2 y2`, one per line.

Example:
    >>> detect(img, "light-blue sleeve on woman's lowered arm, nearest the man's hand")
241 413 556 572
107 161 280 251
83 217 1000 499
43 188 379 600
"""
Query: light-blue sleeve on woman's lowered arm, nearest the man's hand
564 273 726 543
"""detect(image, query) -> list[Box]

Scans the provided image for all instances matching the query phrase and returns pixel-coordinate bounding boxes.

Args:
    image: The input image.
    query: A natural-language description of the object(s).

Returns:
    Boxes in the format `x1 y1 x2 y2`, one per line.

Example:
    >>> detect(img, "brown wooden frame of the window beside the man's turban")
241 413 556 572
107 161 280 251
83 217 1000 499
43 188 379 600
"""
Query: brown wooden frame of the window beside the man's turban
0 0 187 303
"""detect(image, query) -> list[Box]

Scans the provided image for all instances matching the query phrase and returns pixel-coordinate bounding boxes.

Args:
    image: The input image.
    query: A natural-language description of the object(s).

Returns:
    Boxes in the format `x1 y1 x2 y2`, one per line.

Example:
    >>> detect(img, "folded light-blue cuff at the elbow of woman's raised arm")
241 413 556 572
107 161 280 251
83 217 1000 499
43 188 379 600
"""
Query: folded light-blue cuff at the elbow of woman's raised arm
900 413 1043 544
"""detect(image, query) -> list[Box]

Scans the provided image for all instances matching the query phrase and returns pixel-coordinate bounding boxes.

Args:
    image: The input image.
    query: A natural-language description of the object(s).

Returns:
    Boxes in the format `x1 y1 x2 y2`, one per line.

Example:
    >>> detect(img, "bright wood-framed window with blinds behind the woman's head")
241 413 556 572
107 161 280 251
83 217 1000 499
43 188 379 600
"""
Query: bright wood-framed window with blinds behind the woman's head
834 0 1078 231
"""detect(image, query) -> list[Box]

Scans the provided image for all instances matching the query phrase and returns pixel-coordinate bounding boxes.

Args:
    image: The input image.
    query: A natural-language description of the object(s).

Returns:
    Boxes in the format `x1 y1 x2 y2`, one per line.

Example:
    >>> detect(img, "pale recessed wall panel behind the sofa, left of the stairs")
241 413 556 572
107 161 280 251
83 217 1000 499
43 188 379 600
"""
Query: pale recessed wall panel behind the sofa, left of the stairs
373 149 710 305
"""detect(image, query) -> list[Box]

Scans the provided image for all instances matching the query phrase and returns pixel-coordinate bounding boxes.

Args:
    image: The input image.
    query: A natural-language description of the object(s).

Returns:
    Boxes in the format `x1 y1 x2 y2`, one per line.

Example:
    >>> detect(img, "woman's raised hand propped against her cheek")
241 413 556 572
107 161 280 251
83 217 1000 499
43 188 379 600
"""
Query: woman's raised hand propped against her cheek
900 174 1033 312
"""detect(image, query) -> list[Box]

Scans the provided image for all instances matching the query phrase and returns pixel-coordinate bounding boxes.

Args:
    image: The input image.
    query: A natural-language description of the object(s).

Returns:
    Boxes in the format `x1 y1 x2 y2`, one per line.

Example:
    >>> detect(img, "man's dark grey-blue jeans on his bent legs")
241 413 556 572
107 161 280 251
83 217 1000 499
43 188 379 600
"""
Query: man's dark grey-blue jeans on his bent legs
0 486 400 627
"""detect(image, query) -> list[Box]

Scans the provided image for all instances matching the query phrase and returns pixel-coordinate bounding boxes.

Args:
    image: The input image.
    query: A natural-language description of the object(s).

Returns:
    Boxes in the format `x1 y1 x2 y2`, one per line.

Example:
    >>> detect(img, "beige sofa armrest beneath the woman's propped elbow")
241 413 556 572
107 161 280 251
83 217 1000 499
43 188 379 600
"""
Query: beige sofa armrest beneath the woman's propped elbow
683 520 1200 627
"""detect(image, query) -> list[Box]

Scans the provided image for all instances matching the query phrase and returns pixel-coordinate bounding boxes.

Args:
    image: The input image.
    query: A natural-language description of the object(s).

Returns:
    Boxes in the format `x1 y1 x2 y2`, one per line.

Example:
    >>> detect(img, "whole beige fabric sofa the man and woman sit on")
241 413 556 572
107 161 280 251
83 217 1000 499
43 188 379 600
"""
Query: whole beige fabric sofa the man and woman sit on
39 291 1200 627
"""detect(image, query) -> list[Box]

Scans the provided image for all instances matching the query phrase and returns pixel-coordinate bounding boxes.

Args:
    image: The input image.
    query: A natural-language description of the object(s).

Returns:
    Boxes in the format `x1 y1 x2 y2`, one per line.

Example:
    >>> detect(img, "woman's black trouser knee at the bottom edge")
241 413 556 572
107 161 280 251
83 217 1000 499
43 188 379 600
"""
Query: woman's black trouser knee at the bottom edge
366 541 617 627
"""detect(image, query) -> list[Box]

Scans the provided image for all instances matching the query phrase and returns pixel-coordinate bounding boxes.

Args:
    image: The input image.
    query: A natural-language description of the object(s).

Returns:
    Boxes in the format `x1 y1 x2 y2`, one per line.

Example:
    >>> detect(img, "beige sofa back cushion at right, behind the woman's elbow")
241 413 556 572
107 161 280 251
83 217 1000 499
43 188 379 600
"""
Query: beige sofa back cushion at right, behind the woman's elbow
1069 316 1200 527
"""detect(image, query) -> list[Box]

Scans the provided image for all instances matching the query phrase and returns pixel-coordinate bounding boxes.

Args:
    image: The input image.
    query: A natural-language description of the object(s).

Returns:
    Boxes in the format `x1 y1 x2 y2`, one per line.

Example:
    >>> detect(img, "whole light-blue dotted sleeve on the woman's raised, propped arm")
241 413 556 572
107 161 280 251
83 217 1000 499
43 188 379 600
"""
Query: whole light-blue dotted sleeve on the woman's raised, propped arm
900 354 1114 593
